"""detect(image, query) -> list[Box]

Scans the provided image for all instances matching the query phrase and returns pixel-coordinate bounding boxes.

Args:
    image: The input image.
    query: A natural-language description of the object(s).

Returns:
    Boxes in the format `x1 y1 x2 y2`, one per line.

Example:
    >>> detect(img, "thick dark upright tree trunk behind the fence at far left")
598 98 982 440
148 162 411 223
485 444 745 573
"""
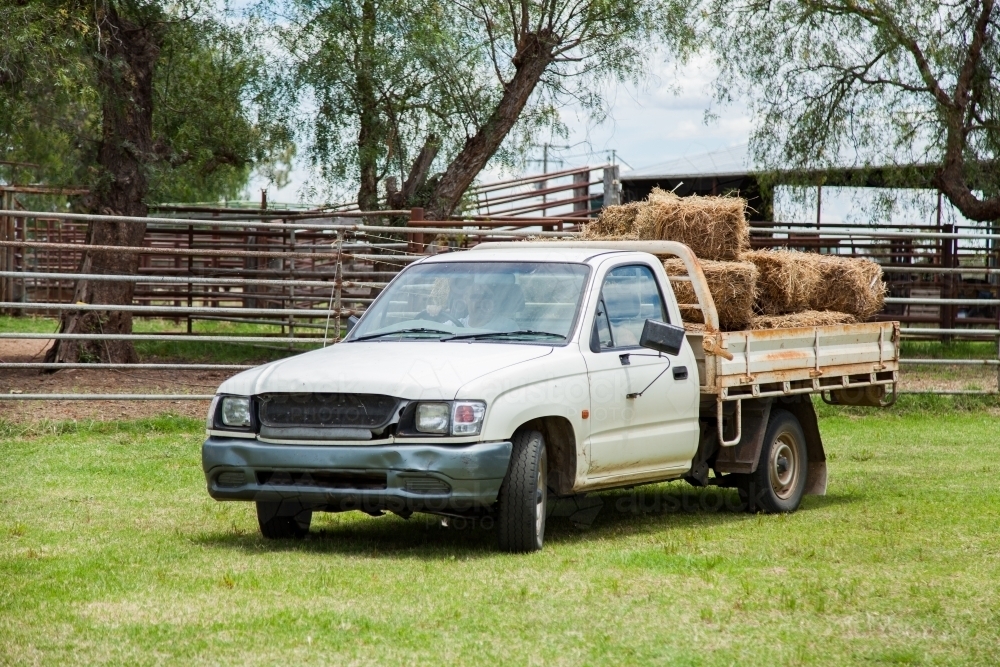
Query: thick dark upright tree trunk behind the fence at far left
45 2 159 363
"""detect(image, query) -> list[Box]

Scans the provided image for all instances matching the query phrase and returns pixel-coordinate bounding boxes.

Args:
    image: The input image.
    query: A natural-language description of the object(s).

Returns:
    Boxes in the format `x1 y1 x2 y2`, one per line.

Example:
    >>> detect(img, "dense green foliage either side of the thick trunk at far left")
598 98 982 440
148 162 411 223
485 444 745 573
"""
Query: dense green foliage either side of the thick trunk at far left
0 0 292 203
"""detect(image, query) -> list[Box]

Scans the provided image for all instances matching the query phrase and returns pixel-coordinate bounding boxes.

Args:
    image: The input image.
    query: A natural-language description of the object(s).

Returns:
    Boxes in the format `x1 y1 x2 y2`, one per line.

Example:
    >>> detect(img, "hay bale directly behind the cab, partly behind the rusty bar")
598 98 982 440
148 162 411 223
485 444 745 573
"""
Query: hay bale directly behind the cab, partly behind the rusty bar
663 258 758 331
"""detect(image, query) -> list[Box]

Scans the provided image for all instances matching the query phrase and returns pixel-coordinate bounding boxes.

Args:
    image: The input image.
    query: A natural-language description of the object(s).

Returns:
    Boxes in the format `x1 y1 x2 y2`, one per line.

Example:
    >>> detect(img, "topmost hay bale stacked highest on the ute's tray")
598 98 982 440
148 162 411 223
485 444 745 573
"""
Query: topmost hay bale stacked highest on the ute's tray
633 188 750 261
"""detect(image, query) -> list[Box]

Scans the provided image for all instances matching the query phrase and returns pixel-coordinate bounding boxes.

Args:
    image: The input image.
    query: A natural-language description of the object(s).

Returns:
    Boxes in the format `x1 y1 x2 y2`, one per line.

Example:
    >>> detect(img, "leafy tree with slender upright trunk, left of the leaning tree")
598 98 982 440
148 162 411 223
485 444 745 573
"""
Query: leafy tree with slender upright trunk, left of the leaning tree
270 0 476 210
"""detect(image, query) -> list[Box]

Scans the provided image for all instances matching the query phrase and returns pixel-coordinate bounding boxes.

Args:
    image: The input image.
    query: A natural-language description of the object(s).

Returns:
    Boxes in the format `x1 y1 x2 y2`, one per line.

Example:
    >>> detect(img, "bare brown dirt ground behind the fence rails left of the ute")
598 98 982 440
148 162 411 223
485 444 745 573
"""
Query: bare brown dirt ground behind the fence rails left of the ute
0 340 225 422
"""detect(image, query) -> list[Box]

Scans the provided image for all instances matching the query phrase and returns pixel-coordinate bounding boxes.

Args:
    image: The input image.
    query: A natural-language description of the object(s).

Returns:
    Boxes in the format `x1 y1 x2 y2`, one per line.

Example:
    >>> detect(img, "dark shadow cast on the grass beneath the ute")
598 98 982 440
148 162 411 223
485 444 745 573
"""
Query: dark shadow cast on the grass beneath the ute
193 483 854 560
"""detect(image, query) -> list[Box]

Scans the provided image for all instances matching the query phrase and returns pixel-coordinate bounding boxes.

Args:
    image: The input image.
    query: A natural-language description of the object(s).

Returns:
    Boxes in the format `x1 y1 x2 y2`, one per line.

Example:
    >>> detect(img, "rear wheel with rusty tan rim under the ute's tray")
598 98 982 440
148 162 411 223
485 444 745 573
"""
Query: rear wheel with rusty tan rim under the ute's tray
739 410 809 514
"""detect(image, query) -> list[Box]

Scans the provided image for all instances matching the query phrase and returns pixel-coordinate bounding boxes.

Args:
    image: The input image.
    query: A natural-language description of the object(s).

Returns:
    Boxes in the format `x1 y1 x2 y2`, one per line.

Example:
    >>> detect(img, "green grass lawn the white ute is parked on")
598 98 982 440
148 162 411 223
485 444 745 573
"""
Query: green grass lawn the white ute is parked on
0 400 1000 665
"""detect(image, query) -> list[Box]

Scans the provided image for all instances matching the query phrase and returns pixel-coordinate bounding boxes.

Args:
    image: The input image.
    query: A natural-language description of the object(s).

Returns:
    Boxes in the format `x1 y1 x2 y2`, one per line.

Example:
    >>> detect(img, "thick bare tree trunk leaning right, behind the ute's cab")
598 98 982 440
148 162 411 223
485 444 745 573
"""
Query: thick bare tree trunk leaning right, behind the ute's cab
429 33 556 220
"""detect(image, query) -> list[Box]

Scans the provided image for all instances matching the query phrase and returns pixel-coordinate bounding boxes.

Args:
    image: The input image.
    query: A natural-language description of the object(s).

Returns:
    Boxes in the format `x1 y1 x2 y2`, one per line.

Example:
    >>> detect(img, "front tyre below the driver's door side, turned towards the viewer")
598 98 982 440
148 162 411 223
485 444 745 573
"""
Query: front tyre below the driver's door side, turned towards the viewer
497 431 549 553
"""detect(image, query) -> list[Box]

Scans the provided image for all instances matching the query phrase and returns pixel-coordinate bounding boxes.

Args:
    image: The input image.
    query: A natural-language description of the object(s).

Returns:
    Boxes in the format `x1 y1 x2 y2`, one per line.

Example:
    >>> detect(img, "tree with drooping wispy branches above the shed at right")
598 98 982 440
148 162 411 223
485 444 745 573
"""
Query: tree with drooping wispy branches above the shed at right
701 0 1000 221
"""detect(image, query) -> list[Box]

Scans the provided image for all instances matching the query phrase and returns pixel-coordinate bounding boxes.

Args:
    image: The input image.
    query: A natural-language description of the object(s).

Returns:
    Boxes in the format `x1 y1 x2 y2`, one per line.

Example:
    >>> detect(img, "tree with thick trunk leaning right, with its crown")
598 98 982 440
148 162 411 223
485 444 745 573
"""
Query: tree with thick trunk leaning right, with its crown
430 0 689 217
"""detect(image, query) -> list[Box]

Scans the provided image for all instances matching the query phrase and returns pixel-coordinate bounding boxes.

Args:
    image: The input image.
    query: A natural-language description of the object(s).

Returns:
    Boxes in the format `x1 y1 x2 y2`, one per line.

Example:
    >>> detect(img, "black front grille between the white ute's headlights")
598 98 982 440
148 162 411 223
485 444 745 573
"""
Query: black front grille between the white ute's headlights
260 393 399 429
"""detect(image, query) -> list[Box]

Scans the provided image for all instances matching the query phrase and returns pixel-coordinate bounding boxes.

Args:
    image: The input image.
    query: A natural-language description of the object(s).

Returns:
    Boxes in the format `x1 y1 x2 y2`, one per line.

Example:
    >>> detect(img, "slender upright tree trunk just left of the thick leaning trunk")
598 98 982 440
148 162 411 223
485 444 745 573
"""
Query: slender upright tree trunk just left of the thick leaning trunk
355 0 385 211
